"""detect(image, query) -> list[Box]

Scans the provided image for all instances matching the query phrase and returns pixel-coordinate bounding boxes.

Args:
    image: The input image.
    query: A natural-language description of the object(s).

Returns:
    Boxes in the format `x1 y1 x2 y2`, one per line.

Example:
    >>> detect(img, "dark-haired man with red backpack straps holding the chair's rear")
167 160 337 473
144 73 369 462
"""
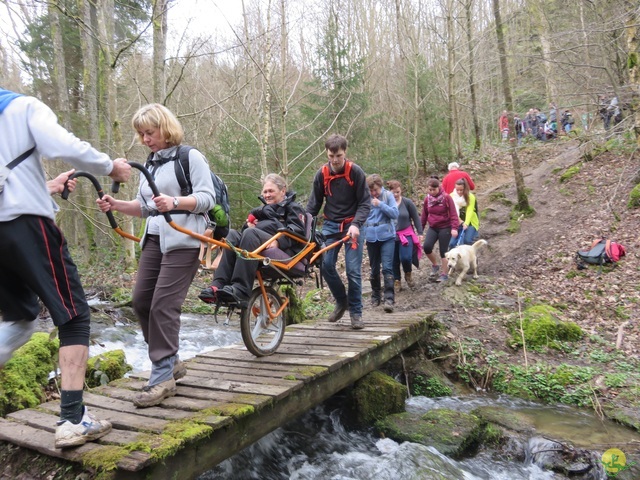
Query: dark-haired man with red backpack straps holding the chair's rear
307 134 371 330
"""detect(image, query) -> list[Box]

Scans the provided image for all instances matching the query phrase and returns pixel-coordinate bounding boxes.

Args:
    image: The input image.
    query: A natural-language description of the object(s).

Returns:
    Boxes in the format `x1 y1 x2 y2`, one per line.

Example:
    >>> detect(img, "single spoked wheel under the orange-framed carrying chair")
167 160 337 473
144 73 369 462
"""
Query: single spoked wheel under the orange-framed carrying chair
240 287 285 357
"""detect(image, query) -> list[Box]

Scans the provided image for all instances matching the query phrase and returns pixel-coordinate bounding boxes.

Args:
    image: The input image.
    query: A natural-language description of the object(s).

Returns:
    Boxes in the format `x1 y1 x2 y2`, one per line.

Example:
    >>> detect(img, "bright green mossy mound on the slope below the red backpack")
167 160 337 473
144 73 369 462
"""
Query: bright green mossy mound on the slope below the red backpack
510 304 583 349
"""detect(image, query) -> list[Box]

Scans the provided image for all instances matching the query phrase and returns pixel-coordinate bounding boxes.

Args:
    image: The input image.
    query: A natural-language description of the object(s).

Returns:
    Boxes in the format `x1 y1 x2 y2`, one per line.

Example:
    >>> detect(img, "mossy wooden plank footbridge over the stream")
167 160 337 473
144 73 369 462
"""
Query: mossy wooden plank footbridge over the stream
0 311 430 480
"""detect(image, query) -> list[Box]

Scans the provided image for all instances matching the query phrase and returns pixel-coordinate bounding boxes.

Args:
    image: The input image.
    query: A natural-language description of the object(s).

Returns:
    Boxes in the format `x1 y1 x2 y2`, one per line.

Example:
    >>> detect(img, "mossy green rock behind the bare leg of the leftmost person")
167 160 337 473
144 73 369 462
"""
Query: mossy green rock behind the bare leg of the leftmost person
0 332 60 416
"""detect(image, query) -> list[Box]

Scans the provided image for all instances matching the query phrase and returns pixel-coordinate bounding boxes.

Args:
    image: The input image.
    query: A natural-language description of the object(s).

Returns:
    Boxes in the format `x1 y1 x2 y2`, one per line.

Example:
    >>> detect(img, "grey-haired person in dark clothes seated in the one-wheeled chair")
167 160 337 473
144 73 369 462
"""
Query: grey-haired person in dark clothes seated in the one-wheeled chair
198 173 306 306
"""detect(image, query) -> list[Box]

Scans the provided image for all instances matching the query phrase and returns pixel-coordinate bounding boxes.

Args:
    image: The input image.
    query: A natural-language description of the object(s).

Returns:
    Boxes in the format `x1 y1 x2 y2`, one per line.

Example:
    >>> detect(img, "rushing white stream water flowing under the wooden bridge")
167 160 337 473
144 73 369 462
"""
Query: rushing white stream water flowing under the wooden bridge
90 315 640 480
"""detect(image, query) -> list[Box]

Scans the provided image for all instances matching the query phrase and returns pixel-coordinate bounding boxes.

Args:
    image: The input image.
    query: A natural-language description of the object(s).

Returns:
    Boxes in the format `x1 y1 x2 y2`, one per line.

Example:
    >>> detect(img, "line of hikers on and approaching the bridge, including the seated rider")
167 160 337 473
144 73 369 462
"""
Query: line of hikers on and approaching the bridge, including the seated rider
0 89 479 448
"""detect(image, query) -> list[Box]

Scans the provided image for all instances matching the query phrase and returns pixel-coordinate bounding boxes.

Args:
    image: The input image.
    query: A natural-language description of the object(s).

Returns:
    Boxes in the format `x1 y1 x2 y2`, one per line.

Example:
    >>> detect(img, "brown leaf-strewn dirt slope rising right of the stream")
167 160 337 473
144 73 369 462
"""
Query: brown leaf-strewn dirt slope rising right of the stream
364 133 640 430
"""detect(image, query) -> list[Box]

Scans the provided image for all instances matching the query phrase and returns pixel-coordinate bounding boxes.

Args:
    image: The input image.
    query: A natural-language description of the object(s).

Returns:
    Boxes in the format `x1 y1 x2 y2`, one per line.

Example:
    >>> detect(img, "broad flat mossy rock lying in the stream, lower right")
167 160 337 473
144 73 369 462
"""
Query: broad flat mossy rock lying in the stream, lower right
376 408 486 458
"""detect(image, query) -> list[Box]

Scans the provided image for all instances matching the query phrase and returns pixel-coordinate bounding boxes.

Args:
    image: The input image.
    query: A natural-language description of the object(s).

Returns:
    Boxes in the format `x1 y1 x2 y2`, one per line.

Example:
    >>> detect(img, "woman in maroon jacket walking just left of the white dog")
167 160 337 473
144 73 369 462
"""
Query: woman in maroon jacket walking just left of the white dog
420 177 460 282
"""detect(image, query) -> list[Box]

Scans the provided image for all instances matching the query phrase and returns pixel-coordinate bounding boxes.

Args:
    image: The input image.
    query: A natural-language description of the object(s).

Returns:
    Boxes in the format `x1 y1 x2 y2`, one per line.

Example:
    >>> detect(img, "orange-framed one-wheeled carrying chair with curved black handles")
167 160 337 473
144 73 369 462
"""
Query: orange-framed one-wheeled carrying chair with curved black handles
62 162 350 357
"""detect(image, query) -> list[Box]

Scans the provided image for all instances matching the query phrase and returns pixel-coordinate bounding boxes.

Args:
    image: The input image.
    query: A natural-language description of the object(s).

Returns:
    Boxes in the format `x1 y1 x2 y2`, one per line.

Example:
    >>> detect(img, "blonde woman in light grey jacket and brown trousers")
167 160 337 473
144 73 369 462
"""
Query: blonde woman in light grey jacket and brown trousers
97 103 216 407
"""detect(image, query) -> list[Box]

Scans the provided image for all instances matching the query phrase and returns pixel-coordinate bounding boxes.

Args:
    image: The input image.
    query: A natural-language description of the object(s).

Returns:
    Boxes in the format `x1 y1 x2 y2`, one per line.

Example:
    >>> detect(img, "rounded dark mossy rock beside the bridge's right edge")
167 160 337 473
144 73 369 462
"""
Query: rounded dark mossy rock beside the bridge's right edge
350 371 407 425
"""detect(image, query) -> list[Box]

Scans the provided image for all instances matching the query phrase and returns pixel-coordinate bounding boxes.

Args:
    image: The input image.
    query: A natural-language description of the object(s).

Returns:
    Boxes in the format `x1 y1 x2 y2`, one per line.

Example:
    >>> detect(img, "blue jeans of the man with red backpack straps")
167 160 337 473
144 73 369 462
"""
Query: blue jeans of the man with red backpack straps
322 220 364 315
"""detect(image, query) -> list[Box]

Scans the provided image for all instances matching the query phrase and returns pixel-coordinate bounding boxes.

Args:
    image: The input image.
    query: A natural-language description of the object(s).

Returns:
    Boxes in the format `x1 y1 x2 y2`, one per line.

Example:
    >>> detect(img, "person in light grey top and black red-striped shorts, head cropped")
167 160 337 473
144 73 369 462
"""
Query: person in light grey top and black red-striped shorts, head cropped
0 89 131 448
